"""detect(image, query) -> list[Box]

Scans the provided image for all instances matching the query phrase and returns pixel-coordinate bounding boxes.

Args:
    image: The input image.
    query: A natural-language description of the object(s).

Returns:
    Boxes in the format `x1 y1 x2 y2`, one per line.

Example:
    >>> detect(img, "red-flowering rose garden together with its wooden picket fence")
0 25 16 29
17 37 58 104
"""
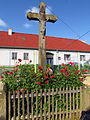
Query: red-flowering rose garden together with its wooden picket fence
0 59 88 120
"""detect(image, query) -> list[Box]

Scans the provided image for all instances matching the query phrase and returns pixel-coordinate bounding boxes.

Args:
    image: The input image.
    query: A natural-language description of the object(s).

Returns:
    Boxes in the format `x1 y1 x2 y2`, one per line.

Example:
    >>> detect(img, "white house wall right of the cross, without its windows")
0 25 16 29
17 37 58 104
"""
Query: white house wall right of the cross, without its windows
48 51 90 65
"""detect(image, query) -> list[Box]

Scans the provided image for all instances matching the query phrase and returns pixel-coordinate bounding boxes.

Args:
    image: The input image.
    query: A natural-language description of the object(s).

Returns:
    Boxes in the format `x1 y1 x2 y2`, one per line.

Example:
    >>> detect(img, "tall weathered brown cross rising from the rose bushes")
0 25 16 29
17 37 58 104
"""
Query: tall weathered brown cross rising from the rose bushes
27 2 57 71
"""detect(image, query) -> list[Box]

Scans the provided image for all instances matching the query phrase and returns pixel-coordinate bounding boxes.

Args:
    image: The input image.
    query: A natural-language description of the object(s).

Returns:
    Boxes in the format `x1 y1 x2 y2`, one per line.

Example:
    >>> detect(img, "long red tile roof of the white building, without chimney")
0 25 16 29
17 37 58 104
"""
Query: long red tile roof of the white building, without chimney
0 31 90 52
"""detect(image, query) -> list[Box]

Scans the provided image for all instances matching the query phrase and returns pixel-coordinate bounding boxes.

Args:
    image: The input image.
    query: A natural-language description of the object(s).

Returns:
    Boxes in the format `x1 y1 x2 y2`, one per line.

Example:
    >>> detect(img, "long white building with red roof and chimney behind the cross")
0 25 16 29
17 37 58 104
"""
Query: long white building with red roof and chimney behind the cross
0 29 90 65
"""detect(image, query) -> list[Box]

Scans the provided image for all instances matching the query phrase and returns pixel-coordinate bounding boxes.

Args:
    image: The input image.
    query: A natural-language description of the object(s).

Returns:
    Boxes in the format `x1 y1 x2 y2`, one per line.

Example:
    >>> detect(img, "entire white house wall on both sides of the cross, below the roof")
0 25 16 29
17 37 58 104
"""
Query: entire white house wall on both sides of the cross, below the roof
0 48 90 66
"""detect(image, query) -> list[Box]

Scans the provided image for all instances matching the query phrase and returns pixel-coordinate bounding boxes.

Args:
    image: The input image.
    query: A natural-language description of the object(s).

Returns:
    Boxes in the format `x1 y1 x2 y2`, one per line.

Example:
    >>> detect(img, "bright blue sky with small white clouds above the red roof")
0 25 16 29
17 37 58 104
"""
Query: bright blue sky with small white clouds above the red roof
0 0 90 44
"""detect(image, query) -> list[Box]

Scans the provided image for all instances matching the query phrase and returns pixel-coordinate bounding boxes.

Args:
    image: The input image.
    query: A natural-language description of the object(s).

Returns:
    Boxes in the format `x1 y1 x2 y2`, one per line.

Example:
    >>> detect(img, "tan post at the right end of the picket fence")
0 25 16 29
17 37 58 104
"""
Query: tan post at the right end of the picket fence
82 86 90 110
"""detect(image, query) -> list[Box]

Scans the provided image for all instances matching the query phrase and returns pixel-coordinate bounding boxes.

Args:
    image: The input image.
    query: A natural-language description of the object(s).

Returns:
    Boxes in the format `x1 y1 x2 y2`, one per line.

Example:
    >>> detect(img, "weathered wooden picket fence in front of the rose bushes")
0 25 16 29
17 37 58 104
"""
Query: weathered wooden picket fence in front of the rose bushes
8 87 82 120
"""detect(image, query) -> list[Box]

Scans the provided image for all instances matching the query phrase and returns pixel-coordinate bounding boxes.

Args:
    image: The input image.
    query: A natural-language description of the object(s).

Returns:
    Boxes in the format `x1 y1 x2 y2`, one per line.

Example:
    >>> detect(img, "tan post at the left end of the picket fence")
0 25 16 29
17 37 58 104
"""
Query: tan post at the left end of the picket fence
0 80 6 120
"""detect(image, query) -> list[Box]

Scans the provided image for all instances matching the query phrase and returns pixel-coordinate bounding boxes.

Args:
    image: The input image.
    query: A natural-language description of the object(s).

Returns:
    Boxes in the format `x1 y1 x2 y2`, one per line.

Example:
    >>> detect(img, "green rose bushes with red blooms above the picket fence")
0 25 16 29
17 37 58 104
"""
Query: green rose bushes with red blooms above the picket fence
2 63 87 91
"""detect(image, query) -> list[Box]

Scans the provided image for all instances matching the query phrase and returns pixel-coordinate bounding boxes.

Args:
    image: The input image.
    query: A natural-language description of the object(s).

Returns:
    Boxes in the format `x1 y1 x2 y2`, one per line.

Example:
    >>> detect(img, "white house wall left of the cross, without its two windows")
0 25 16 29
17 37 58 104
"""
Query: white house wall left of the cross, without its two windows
0 49 38 66
